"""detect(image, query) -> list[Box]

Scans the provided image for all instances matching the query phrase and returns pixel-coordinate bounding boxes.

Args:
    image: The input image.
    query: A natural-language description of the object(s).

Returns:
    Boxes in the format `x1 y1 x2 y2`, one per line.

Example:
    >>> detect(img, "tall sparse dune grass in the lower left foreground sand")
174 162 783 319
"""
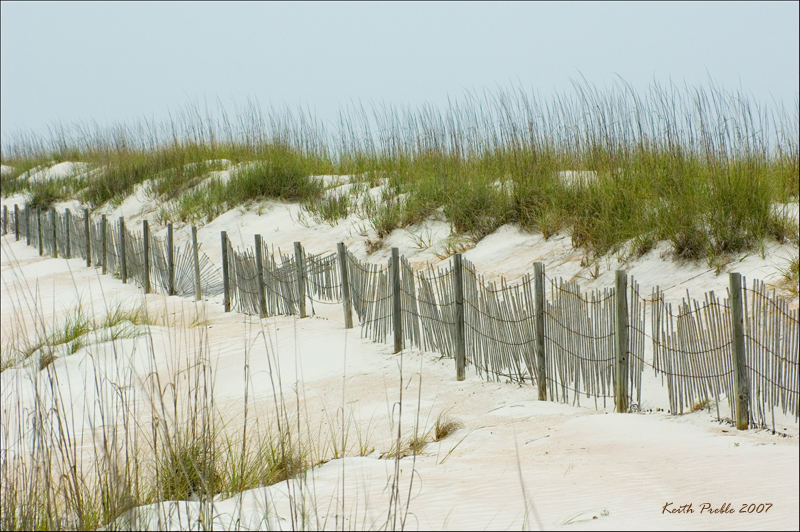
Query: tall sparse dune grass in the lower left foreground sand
0 241 432 530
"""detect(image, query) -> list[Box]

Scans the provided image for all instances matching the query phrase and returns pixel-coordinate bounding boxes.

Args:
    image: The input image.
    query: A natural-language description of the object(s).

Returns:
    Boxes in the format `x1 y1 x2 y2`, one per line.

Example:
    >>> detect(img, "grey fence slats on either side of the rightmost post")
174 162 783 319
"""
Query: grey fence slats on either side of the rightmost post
652 281 800 430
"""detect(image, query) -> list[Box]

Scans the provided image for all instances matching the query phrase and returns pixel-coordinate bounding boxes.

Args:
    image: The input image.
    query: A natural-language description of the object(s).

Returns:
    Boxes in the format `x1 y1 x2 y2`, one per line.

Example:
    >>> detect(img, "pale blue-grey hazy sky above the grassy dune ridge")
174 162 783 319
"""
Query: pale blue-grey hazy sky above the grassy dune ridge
0 1 800 148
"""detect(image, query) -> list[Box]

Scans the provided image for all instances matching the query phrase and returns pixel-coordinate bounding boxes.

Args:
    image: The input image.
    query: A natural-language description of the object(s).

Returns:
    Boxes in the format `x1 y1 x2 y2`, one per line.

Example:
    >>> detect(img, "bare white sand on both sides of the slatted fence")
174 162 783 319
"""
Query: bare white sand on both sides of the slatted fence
0 198 800 530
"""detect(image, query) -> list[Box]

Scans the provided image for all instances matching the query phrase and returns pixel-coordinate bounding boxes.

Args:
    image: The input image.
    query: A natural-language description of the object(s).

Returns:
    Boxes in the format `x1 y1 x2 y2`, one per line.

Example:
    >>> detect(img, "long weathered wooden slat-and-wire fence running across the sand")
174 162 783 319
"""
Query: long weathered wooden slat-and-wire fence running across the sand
3 206 800 430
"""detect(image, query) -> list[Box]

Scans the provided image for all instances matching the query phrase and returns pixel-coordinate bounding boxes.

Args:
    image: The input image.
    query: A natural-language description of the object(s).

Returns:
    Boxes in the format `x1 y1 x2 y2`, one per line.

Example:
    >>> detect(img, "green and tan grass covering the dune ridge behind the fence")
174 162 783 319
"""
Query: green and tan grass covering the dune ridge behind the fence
2 82 800 261
